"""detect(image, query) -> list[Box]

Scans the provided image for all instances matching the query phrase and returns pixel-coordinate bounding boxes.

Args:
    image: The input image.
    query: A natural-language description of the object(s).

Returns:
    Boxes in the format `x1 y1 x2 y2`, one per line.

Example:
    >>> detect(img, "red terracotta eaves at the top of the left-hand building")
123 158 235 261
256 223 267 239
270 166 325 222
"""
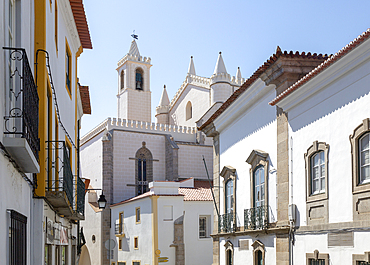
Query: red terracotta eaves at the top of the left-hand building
69 0 92 49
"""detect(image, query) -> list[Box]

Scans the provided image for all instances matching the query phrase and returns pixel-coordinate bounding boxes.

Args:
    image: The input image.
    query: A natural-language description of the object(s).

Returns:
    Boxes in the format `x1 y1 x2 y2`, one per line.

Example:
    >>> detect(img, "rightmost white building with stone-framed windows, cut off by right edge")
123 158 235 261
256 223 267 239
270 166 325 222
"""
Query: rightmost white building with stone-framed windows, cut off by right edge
271 30 370 265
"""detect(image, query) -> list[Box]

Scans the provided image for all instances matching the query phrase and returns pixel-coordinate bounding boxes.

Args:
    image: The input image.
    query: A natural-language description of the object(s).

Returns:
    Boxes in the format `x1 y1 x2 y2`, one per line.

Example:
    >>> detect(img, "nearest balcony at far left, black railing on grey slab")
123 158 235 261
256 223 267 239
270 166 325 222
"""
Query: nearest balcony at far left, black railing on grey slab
3 47 40 173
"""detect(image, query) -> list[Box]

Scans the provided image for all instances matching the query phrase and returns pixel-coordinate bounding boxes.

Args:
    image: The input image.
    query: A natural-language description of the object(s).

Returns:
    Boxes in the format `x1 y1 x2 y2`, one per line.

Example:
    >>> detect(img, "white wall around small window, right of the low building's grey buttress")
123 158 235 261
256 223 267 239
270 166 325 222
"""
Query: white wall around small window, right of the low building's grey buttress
184 201 213 265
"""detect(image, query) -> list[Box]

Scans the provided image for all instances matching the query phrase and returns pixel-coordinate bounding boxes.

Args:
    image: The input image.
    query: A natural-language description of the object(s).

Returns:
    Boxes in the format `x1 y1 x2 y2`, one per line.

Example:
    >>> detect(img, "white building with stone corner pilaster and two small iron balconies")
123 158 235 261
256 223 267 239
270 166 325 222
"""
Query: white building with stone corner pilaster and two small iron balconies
197 47 327 265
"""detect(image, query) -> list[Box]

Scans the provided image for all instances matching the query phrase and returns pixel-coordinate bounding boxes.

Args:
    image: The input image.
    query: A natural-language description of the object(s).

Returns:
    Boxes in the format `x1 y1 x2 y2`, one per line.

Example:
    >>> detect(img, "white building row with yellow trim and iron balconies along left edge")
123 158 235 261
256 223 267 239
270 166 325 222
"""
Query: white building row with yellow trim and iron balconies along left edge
0 0 91 265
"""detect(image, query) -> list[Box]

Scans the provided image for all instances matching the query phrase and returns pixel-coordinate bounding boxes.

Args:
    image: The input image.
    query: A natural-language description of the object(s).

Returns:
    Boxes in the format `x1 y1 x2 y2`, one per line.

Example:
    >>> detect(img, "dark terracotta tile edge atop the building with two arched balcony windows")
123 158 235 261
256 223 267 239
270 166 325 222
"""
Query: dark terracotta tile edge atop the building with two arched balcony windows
198 46 328 130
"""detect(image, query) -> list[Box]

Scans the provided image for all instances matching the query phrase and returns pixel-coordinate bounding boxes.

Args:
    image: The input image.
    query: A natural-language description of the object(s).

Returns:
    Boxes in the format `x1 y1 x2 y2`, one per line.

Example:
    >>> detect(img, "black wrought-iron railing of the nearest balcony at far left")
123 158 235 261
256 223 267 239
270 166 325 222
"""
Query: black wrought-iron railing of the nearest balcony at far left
3 47 40 161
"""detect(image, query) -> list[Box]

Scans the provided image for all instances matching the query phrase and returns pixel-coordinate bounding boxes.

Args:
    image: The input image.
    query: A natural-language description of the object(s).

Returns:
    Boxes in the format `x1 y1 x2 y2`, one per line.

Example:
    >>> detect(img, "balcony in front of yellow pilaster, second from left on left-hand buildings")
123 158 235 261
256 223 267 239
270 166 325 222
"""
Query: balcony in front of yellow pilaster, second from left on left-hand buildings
45 141 73 217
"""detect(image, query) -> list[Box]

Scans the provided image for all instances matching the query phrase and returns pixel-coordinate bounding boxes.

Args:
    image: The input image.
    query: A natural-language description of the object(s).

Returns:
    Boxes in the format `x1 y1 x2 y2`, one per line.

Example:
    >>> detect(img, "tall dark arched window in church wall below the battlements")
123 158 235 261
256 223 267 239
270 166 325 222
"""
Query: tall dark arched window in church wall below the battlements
135 142 153 195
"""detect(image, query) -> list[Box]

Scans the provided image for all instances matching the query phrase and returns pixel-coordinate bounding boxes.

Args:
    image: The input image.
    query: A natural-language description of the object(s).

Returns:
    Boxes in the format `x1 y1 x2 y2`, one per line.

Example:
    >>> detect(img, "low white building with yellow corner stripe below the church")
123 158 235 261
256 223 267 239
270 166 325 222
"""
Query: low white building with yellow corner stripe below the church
110 179 213 265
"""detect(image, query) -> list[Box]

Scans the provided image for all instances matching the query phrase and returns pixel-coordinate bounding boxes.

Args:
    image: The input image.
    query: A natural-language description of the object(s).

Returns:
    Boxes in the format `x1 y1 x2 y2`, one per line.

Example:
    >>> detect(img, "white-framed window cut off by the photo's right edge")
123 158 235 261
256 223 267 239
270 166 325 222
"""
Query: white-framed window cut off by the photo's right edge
359 133 370 184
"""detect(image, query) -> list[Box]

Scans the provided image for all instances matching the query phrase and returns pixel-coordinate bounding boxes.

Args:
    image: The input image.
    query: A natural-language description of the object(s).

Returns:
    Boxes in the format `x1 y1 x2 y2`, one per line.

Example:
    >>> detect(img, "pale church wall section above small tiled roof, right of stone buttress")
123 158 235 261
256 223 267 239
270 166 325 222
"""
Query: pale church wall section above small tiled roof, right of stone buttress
177 142 213 179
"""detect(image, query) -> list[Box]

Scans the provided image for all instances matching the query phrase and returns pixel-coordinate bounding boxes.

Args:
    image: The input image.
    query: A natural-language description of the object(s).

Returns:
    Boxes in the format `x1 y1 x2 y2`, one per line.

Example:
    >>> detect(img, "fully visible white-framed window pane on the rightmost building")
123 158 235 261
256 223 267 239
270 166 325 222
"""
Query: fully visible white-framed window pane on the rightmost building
310 151 326 195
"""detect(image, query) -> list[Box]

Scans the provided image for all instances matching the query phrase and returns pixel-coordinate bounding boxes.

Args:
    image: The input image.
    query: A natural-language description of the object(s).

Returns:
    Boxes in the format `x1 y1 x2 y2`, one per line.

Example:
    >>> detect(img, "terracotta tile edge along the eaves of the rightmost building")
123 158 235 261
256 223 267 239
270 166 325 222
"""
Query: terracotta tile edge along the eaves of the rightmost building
269 28 370 106
